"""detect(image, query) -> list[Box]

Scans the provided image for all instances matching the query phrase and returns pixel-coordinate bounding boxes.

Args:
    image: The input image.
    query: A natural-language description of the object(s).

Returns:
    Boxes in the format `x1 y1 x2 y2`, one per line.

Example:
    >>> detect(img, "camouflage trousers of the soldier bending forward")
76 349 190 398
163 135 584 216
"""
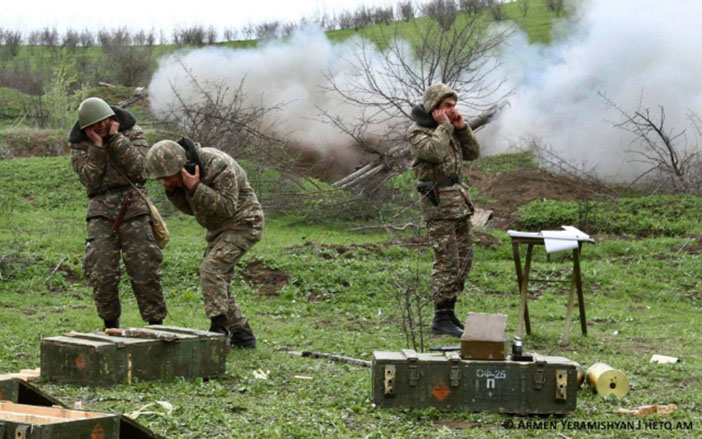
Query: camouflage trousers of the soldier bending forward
200 227 262 332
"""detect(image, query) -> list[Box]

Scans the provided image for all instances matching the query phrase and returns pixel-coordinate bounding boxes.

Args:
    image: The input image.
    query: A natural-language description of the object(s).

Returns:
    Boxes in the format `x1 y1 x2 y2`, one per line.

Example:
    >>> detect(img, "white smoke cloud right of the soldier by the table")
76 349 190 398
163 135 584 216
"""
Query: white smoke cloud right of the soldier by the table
483 0 702 182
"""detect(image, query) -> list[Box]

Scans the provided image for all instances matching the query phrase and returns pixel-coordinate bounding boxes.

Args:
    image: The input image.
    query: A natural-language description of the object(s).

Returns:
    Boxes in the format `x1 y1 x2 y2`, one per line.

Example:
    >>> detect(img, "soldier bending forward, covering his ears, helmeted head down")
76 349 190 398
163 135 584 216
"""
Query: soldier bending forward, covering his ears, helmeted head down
147 139 263 348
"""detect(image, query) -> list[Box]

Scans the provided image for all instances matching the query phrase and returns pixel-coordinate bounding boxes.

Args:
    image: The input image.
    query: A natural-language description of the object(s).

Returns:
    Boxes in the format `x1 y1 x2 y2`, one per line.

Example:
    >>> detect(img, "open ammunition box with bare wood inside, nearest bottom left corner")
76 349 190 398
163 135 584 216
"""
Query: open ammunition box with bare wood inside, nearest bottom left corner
0 402 120 439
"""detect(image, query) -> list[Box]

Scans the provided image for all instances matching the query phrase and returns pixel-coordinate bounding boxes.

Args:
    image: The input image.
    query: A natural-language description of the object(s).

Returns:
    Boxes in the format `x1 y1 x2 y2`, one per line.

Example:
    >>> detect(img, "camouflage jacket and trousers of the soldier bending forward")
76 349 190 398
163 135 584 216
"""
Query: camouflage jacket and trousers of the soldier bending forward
167 148 263 333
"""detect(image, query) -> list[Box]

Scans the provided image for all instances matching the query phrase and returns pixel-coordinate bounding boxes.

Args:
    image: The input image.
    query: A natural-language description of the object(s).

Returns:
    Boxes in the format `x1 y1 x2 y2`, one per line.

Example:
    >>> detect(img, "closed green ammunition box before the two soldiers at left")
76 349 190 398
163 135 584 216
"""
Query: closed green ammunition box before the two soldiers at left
41 326 226 386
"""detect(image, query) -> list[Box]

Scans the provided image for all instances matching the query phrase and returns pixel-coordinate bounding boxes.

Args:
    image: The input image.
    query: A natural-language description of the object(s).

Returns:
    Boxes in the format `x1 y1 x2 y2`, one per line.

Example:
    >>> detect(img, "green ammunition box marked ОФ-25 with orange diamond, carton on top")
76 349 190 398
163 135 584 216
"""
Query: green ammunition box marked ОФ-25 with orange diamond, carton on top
372 349 577 415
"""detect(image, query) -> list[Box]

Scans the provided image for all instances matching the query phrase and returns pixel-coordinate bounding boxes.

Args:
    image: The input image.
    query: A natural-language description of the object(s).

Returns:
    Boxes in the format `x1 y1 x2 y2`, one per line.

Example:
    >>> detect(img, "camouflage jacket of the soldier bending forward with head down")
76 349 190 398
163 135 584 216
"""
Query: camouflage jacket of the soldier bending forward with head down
167 148 263 241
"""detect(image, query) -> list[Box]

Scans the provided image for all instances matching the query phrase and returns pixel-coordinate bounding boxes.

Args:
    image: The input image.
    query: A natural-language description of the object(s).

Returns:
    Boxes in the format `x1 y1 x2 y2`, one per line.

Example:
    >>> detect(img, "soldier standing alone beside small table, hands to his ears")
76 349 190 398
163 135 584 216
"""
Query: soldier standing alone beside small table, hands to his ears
407 84 480 337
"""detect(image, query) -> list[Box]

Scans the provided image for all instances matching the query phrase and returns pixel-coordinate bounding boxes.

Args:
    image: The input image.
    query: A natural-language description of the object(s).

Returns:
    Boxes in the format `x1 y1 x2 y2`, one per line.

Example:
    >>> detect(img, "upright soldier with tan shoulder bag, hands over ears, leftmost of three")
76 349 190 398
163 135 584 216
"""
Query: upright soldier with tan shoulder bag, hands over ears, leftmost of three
69 98 167 328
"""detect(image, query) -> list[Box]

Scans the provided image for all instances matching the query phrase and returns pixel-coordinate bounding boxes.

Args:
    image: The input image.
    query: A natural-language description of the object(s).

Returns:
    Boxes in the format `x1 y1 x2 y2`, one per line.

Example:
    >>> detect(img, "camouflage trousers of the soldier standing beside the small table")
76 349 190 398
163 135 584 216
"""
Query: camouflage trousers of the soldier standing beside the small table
427 216 473 303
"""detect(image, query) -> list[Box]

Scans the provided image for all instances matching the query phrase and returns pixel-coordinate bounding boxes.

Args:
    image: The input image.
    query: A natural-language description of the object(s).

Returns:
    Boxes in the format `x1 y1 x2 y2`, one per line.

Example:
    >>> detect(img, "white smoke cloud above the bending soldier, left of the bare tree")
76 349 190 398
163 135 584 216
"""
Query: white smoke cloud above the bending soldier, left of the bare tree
149 27 394 156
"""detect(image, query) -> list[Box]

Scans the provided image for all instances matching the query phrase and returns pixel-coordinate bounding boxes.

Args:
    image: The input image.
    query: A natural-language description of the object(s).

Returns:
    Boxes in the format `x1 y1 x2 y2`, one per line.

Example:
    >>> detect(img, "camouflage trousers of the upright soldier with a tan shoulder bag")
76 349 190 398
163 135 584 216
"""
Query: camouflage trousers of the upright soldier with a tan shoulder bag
83 215 167 322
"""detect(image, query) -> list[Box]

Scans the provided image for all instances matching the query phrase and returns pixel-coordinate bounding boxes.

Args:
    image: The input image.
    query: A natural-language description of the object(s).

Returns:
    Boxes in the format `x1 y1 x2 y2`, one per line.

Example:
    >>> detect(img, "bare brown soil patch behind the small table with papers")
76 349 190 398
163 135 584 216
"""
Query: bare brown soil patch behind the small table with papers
469 169 598 230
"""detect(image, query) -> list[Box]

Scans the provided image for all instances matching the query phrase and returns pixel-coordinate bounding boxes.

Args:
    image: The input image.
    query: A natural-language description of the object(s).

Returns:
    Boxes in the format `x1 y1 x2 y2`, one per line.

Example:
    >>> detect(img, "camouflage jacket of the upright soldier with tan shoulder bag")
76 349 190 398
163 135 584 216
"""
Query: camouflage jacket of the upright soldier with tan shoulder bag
69 107 149 221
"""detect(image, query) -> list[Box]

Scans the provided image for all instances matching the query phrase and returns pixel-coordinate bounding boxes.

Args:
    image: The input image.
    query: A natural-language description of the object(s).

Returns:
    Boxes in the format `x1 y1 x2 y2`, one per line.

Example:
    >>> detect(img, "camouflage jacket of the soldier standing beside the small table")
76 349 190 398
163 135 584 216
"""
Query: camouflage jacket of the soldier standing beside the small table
407 106 480 221
